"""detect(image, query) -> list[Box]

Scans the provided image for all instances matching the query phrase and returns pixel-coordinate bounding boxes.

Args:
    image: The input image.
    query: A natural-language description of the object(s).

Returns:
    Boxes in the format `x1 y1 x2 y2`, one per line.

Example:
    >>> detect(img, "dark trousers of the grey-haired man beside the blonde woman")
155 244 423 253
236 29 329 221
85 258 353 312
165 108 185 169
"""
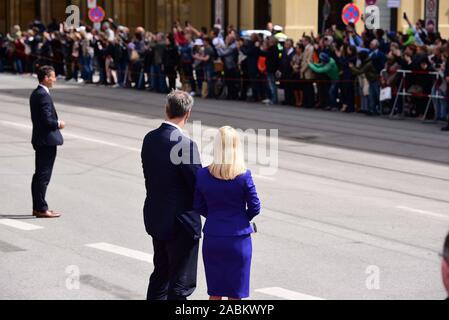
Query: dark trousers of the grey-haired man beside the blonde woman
147 222 199 301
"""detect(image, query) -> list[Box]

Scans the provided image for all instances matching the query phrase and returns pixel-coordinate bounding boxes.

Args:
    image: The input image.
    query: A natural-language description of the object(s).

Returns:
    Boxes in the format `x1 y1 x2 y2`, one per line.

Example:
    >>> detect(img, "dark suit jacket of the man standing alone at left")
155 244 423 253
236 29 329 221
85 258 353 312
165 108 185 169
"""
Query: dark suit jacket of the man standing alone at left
30 86 64 146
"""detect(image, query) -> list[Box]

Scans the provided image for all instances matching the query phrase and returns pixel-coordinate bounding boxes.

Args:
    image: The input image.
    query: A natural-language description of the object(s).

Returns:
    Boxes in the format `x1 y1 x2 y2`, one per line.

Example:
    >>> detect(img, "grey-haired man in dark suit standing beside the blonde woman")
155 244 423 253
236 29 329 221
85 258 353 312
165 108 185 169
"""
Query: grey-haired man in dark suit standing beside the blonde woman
142 91 201 300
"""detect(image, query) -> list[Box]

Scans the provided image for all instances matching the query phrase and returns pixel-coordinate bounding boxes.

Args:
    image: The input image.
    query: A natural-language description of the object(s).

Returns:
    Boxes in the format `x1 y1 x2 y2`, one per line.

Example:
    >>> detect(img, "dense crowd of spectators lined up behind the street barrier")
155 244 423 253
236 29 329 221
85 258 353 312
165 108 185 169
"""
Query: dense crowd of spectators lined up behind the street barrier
0 14 449 130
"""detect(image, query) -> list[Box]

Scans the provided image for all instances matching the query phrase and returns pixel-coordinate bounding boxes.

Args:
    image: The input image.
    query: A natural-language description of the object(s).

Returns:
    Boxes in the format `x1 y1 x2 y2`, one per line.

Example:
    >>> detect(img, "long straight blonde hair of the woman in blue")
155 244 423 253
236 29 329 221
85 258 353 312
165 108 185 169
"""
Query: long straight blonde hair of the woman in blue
209 127 247 180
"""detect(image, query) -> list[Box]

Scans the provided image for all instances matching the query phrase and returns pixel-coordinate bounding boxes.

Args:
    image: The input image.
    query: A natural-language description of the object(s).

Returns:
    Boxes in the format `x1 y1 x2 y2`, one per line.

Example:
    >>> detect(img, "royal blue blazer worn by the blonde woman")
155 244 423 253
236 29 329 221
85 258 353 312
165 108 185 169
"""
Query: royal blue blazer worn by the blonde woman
194 168 260 237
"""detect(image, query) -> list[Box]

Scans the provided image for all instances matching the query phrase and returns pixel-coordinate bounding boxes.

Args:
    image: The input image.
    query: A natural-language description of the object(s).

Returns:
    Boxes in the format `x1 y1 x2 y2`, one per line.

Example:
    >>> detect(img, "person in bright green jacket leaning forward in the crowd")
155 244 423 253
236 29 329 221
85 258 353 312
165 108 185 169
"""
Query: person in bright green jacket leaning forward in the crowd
309 52 340 111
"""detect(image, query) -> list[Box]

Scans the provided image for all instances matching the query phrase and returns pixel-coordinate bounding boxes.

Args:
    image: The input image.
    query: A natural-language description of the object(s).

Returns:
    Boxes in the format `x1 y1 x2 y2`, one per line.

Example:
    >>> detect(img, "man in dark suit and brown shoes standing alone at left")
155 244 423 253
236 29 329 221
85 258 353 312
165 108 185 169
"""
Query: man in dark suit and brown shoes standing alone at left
30 66 65 218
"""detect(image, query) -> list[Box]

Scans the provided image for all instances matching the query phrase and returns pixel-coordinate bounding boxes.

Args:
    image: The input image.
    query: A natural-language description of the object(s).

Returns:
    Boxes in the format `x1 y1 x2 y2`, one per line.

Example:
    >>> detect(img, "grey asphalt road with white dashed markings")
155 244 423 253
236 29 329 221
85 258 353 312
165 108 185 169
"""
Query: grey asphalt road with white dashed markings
0 74 449 300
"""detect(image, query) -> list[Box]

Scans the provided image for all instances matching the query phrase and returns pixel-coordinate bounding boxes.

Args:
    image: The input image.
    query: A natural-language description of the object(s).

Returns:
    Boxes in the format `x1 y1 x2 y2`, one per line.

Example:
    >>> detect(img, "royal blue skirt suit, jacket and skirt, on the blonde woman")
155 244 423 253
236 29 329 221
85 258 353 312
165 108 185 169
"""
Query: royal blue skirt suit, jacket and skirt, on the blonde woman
194 168 260 299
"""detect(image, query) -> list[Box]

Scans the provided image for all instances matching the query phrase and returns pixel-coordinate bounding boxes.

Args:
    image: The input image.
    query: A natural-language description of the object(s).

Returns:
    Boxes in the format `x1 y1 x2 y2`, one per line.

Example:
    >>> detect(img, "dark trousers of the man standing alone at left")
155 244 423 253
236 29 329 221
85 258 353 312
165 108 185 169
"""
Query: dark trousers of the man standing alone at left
31 146 56 212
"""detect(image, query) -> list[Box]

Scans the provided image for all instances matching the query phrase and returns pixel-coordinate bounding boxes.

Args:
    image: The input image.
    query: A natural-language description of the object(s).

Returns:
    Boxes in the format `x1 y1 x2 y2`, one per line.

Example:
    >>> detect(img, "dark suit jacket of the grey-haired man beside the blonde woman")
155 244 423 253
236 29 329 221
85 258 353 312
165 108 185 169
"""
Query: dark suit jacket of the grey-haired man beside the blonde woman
142 123 201 241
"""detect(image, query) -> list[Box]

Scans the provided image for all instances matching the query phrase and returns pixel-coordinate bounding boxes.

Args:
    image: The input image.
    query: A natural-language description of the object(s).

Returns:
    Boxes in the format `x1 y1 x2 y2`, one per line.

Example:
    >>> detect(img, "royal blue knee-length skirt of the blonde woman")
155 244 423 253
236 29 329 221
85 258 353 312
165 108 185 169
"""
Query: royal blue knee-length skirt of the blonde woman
203 235 253 299
